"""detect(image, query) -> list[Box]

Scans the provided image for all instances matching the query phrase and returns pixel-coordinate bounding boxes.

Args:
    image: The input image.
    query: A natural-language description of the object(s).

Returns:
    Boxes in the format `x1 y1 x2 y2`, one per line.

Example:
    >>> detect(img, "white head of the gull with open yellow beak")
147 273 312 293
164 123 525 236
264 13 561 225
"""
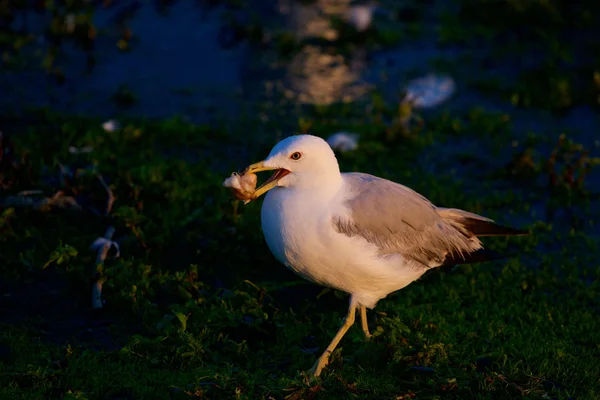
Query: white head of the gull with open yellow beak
243 135 342 201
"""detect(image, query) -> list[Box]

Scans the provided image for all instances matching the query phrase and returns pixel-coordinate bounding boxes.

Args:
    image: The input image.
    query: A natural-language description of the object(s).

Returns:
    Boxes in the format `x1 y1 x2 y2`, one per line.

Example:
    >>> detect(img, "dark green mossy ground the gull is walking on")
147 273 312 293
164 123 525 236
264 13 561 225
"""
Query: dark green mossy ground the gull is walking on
0 2 600 399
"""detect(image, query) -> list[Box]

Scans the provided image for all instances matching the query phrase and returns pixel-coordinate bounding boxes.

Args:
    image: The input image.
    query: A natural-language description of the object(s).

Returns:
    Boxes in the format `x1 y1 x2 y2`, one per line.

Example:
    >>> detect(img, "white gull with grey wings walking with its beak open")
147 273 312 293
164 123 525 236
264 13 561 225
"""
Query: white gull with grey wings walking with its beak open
243 135 526 376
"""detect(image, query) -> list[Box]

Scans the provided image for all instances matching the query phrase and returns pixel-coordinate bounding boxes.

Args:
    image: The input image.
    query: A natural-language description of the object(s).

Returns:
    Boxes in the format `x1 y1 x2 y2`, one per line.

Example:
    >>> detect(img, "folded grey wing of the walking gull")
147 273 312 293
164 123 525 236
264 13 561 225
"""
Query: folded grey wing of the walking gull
333 173 483 268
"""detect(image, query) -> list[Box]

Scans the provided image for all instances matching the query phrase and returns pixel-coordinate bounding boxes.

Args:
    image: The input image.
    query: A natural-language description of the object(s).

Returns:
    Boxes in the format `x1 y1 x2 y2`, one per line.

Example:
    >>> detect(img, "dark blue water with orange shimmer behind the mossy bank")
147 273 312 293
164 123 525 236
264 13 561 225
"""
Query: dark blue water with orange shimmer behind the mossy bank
0 0 600 148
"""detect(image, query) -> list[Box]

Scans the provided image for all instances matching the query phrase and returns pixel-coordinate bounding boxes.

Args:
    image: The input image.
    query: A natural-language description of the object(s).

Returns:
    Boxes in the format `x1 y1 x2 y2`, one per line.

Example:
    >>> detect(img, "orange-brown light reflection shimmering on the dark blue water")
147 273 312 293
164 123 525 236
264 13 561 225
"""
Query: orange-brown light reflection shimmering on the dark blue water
278 0 370 104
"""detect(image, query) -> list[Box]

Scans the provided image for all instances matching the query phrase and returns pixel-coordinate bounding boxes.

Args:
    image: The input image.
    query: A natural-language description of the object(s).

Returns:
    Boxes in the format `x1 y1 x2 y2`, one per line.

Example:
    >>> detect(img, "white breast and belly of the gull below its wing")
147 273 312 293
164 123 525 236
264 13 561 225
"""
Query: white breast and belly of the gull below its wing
261 188 424 307
